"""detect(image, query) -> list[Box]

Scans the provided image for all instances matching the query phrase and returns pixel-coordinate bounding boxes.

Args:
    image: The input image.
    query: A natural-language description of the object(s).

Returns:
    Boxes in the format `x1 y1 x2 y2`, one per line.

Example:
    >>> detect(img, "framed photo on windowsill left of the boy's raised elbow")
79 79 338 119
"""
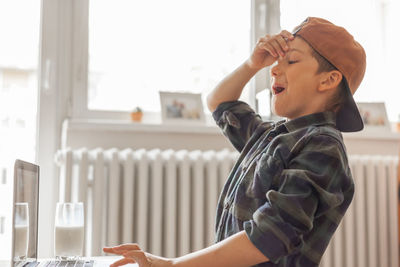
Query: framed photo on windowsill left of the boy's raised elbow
159 91 205 125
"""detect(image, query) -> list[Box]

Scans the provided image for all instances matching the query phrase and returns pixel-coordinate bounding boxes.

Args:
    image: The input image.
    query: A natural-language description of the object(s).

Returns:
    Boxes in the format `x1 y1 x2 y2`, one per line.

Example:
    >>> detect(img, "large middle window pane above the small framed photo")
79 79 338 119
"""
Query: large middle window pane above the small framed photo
88 0 250 111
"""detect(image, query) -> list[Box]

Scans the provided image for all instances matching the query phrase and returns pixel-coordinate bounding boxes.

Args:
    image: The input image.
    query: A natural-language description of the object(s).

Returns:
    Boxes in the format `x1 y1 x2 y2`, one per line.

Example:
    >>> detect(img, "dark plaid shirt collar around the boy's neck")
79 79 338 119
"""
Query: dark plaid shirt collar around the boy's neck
283 111 336 132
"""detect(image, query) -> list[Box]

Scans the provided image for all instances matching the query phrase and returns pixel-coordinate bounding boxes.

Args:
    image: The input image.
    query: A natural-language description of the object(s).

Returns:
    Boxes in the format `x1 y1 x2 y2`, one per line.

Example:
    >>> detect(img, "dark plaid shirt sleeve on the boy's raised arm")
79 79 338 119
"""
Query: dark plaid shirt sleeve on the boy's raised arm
213 101 262 152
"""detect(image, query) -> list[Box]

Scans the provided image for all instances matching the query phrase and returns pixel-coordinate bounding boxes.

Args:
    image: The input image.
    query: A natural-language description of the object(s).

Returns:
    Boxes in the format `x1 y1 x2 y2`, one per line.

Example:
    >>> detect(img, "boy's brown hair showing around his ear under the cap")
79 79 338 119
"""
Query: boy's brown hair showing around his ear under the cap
311 47 346 112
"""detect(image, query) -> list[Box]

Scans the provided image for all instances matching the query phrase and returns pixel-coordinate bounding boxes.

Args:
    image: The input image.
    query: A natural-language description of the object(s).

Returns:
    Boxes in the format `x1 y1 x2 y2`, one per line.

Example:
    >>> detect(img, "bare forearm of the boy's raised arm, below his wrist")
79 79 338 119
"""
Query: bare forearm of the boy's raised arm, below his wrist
207 61 259 112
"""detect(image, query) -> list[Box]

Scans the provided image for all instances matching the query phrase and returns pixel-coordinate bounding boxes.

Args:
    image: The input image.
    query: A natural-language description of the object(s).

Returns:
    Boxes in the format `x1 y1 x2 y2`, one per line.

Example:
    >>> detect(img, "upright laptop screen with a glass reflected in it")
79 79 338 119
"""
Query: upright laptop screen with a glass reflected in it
12 160 39 263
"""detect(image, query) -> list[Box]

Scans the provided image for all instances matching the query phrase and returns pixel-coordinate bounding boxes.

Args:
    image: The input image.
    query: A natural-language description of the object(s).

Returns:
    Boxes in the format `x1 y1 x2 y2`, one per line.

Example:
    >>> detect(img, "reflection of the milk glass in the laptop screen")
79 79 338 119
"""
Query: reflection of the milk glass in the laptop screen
14 202 29 261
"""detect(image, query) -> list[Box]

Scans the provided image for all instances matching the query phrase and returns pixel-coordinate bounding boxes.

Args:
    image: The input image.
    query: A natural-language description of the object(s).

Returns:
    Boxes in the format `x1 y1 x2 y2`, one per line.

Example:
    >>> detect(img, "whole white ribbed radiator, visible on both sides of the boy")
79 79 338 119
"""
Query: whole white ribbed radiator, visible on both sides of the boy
56 149 398 267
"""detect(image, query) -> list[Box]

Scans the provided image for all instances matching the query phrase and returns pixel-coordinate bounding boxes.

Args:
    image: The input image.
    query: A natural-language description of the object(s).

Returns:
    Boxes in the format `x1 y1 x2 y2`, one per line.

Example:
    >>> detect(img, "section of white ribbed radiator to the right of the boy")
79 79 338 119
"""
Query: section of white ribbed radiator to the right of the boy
321 155 399 267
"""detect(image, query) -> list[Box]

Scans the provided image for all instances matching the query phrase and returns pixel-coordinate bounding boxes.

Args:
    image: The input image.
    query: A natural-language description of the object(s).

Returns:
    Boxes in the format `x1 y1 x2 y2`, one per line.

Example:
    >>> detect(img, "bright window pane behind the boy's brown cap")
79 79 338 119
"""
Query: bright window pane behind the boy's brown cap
281 0 400 121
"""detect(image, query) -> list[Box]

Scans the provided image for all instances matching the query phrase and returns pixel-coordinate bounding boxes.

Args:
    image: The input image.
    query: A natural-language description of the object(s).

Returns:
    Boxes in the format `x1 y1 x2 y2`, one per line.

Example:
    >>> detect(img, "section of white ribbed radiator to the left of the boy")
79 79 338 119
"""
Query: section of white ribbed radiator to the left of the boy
56 149 238 257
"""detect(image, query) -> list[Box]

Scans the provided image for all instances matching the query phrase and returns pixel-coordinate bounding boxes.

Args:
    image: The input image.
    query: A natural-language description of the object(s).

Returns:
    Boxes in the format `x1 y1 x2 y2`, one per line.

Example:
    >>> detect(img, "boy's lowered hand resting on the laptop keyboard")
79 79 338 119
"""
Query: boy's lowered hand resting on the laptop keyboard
103 244 172 267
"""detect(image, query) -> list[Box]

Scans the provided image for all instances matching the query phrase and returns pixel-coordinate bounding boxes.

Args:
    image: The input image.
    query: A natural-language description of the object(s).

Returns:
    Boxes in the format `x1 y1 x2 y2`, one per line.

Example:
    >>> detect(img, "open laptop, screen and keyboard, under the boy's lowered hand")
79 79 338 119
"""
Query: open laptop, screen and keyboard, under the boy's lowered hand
9 160 125 267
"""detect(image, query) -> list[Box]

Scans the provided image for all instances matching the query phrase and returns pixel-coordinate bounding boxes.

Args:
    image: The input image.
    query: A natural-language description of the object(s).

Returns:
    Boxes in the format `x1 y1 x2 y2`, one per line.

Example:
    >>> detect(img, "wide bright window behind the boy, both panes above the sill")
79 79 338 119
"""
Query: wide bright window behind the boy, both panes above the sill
72 0 400 121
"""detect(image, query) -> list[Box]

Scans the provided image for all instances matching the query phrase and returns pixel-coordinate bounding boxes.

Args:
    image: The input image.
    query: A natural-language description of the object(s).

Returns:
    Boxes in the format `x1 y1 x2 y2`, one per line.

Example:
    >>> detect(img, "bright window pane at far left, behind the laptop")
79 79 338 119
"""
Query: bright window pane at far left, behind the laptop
0 0 40 259
